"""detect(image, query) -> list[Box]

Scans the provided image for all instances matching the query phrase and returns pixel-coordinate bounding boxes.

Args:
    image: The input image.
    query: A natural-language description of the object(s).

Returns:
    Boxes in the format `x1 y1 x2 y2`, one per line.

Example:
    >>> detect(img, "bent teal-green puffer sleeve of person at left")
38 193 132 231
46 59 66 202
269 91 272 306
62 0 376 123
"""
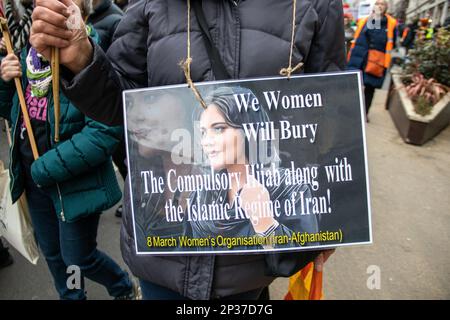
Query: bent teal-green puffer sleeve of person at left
31 114 123 187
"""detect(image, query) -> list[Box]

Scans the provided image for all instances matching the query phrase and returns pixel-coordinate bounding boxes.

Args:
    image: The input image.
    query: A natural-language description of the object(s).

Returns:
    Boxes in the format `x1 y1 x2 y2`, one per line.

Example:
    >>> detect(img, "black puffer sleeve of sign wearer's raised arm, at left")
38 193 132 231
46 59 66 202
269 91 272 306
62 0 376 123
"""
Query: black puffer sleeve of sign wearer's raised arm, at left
61 1 148 125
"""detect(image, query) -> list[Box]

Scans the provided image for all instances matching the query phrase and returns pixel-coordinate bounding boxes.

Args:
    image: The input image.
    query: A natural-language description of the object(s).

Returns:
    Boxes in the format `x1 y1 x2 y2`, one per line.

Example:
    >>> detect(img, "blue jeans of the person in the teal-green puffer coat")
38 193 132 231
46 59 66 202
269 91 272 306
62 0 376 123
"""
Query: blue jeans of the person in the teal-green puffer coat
25 179 132 300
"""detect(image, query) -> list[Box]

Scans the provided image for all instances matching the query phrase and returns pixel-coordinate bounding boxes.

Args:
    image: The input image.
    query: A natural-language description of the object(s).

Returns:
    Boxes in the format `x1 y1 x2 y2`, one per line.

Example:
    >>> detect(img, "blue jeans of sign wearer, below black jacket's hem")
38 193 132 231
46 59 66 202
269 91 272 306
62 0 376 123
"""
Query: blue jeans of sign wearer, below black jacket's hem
139 279 263 300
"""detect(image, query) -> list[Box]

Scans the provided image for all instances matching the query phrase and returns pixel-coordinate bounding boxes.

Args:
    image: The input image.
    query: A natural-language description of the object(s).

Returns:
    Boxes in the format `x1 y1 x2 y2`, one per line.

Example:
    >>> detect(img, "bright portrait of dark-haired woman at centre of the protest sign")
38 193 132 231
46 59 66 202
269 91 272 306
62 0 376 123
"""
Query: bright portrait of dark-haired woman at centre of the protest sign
185 87 318 250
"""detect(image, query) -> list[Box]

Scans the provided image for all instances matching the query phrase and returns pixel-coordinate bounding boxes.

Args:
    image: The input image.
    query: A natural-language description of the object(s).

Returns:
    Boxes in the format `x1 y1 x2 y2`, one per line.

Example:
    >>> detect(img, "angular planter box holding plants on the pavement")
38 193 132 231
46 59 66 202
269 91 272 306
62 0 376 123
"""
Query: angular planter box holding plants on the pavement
387 74 450 145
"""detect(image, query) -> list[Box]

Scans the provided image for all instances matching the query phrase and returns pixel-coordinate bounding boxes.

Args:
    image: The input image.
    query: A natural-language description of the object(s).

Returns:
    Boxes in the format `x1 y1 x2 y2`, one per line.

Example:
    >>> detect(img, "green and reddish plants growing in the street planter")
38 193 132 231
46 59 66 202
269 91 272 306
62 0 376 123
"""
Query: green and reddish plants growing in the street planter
403 28 450 115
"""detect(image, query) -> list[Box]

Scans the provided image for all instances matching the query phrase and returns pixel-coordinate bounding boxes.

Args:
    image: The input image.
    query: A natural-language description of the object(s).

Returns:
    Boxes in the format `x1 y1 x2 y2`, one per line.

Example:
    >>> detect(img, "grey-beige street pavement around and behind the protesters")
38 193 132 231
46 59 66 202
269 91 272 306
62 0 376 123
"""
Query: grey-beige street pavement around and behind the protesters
0 90 450 299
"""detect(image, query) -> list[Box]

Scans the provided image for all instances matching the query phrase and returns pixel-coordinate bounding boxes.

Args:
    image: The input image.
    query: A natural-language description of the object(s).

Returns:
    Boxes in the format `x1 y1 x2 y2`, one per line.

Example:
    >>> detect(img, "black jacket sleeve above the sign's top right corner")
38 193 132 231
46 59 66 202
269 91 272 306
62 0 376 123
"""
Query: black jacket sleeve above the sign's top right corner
305 0 345 73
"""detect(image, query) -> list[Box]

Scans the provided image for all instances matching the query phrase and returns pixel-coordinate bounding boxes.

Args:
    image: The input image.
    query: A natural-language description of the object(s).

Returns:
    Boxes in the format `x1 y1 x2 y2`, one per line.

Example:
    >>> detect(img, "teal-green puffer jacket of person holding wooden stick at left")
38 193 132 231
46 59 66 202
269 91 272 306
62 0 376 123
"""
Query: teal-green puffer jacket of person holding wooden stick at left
0 38 123 222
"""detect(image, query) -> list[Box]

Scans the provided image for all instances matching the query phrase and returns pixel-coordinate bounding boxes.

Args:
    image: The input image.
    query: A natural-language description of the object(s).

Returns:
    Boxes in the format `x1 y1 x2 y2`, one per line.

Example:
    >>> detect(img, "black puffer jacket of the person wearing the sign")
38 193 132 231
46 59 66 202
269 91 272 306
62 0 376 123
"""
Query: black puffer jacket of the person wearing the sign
63 0 345 299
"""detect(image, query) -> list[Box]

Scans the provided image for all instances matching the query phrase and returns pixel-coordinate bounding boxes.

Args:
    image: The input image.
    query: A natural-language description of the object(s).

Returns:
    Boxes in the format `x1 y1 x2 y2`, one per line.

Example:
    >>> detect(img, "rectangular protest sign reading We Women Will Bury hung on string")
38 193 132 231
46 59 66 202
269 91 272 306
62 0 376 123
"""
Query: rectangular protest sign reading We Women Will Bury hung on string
124 71 372 254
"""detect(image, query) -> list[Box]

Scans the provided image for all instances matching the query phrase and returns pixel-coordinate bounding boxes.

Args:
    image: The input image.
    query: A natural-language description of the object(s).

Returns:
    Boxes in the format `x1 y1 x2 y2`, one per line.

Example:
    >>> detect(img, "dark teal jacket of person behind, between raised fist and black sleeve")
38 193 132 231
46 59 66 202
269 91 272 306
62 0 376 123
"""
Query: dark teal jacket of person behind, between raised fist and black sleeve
88 0 123 51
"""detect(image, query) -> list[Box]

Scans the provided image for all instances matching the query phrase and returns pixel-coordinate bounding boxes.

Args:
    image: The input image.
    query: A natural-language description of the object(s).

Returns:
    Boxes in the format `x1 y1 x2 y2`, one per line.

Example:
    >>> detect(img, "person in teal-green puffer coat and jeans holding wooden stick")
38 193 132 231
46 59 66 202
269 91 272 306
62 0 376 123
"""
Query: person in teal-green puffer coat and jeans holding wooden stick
0 0 136 300
